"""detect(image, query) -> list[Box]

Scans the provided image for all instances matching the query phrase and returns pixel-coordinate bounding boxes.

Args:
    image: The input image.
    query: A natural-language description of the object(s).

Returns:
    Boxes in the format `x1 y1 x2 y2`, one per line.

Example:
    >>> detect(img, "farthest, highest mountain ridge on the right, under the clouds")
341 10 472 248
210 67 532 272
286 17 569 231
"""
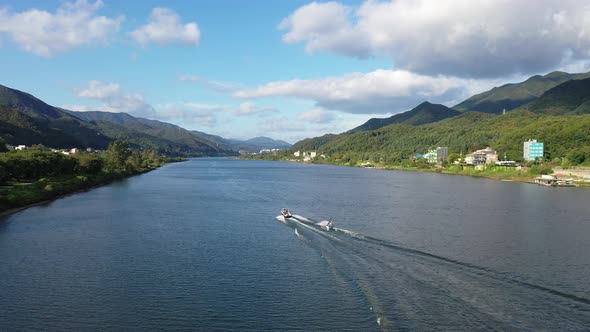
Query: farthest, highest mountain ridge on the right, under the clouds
452 71 590 114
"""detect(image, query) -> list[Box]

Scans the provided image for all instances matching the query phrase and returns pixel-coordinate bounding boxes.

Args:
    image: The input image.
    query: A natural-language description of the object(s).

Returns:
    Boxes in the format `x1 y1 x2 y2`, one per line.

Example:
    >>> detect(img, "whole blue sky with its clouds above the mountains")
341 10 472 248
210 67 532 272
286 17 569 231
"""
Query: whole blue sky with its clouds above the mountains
0 0 590 142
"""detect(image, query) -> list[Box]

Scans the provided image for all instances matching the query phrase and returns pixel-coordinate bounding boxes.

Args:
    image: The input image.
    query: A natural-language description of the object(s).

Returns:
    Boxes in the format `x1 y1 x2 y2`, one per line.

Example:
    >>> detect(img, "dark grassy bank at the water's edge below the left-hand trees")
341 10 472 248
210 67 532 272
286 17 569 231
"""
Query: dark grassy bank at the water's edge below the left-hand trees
0 159 186 216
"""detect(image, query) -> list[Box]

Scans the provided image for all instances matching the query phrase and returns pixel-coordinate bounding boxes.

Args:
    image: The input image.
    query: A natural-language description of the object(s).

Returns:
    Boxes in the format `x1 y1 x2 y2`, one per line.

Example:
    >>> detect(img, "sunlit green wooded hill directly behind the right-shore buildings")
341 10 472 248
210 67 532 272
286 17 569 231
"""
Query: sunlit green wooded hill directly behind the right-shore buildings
310 110 590 160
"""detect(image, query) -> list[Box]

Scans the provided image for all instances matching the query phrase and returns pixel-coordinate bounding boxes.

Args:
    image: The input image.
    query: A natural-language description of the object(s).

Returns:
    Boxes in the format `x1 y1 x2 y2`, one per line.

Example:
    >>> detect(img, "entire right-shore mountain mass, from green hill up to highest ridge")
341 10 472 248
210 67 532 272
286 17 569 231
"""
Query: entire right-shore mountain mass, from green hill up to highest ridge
290 72 590 162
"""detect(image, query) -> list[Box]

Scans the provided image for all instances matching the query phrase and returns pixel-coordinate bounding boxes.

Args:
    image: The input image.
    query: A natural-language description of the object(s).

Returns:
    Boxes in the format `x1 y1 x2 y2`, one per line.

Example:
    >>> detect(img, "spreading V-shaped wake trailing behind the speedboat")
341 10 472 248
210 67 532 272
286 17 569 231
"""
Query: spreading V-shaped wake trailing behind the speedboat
284 215 590 330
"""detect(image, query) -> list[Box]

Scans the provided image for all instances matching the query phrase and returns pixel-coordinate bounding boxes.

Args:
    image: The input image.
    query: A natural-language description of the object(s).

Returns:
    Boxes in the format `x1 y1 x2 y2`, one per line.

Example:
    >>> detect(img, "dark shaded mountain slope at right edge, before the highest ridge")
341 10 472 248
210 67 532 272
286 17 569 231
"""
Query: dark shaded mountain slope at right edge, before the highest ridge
525 78 590 115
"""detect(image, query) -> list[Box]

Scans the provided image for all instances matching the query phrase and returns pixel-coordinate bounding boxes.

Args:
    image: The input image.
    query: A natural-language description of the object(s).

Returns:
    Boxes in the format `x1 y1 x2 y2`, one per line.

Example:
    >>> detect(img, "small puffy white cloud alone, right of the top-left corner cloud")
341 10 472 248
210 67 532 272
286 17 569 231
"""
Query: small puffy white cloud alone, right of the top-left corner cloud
130 8 201 46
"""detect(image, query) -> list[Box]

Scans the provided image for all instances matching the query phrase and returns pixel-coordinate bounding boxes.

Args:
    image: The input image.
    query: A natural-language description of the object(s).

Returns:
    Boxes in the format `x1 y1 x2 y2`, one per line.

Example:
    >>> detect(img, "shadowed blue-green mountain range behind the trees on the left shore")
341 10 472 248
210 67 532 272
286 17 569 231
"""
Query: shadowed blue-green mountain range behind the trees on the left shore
0 85 237 156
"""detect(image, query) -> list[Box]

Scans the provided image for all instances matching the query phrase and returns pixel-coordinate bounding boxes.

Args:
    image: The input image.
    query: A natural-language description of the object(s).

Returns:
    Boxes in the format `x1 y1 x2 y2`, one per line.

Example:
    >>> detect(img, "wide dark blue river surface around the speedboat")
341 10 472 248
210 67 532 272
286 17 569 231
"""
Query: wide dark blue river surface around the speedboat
0 159 590 331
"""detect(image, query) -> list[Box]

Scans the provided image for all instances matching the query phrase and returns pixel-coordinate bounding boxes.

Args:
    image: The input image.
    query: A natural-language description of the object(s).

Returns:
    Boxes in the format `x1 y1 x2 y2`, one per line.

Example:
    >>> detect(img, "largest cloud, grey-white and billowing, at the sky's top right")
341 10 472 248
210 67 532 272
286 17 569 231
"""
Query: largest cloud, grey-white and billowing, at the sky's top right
279 0 590 77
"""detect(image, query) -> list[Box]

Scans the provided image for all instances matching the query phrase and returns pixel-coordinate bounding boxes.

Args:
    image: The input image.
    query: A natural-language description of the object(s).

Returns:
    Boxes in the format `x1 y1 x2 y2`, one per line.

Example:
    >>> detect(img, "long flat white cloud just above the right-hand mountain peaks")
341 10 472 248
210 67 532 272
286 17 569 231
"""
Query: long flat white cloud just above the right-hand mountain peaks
234 69 506 113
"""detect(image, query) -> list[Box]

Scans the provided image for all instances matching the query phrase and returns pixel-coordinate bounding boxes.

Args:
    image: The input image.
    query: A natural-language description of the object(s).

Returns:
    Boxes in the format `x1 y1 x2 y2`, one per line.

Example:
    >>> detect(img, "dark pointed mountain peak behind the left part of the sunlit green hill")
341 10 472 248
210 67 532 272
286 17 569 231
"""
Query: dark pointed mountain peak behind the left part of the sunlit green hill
347 101 461 134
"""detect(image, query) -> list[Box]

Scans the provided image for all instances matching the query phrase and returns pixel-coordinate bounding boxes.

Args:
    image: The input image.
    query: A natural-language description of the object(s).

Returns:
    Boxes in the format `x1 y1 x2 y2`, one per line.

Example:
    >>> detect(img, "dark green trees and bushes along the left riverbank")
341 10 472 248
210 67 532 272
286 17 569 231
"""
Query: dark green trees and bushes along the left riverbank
0 141 184 212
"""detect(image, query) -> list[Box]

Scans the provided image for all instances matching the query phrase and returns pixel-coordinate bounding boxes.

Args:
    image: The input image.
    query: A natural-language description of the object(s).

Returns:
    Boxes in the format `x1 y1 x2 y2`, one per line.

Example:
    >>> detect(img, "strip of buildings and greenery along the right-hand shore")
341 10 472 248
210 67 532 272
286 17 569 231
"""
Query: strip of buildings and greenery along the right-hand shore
249 139 590 187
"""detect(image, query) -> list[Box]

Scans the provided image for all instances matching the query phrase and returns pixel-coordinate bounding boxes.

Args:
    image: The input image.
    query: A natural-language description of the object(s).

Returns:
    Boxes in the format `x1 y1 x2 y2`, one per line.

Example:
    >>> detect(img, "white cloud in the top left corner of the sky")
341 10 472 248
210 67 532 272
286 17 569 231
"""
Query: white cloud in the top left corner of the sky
0 0 123 57
